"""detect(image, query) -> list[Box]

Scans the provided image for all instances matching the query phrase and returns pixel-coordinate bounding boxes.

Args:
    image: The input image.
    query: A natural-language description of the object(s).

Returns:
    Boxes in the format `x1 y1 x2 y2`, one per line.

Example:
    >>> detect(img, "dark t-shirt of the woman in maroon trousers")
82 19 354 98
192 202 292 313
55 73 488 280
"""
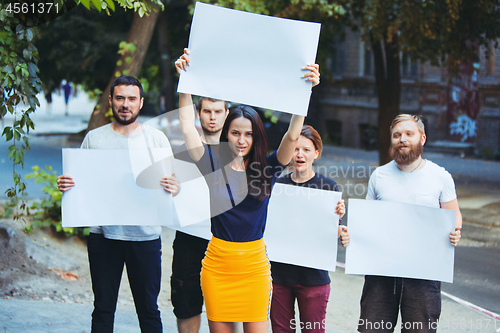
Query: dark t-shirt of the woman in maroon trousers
271 173 338 286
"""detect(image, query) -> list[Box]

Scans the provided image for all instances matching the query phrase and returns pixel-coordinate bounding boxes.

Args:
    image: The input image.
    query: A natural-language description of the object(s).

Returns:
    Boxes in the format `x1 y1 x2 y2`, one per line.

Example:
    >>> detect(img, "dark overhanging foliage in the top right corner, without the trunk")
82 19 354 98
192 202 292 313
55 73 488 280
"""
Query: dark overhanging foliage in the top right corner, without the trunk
339 0 500 66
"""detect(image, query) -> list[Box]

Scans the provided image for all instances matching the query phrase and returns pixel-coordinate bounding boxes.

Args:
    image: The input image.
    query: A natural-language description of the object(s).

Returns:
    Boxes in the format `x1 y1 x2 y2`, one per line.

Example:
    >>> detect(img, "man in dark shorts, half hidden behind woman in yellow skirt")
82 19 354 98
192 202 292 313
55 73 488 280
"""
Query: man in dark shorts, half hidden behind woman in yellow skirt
170 93 229 333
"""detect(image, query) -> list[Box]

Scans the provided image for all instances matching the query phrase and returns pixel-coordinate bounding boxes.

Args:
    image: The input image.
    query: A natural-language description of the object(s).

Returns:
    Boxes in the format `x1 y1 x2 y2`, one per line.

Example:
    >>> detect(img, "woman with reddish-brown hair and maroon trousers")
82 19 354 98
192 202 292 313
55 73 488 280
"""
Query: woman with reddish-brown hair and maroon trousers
271 125 350 333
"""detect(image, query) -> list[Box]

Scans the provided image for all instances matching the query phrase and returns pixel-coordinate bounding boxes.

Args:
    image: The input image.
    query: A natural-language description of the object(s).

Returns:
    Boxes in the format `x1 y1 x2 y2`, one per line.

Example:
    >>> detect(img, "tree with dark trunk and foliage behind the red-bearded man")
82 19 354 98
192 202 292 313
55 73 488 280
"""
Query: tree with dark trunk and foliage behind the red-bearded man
338 0 500 164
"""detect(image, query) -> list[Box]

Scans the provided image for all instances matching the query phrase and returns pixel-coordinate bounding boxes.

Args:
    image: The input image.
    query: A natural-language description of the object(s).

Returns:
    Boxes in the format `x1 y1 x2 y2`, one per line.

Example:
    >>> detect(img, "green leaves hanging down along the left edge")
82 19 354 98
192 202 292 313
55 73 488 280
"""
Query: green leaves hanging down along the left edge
0 3 42 223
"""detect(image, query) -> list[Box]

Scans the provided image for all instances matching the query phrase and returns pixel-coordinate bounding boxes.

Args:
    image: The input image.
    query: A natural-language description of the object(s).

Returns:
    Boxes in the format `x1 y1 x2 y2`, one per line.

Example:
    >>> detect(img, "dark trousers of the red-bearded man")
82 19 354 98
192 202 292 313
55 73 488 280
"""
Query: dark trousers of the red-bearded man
358 275 441 333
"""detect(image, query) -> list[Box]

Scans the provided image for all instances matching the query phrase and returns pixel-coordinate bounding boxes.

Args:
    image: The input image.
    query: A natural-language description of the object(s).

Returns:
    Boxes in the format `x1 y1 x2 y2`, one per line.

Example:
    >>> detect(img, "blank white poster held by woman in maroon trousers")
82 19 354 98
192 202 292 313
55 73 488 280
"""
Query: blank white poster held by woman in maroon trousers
264 184 342 272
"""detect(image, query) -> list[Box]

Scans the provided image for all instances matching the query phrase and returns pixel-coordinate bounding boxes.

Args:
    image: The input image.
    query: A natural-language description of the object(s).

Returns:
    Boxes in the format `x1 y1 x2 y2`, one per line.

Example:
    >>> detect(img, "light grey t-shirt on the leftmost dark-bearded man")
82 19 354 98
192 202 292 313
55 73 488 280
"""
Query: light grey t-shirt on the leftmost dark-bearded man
80 124 170 241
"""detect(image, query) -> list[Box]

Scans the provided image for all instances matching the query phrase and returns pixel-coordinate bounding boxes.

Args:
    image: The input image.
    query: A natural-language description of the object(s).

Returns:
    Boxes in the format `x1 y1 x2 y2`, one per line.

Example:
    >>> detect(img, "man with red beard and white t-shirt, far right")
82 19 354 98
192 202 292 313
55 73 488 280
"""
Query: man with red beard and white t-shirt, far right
358 114 462 332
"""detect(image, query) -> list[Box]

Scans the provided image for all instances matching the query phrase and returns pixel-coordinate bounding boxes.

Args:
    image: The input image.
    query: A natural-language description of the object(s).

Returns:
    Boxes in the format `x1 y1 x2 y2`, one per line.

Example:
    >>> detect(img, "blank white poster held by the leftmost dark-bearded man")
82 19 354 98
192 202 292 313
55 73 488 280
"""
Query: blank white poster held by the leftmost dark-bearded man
62 148 172 227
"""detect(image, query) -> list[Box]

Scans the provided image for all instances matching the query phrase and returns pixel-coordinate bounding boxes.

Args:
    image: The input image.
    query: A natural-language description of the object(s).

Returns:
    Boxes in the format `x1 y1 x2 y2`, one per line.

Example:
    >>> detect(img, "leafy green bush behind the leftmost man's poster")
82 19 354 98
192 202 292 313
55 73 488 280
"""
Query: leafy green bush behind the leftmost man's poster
26 166 90 237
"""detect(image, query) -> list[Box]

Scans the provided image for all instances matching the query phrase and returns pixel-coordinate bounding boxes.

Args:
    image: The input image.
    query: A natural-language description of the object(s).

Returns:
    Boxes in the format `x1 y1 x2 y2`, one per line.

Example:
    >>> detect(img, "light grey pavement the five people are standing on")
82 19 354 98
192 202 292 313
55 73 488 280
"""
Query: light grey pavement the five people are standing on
0 228 500 333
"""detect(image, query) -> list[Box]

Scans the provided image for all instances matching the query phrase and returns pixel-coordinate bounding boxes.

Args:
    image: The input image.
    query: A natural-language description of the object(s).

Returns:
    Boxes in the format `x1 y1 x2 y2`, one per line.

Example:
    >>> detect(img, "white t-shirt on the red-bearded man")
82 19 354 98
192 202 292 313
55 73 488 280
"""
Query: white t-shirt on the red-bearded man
366 160 457 208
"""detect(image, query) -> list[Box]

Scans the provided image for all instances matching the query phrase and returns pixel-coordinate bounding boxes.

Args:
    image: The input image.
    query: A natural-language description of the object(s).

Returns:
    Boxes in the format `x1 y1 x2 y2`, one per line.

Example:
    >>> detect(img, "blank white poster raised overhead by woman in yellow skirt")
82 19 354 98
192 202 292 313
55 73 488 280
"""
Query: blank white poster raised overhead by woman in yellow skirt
177 2 321 116
